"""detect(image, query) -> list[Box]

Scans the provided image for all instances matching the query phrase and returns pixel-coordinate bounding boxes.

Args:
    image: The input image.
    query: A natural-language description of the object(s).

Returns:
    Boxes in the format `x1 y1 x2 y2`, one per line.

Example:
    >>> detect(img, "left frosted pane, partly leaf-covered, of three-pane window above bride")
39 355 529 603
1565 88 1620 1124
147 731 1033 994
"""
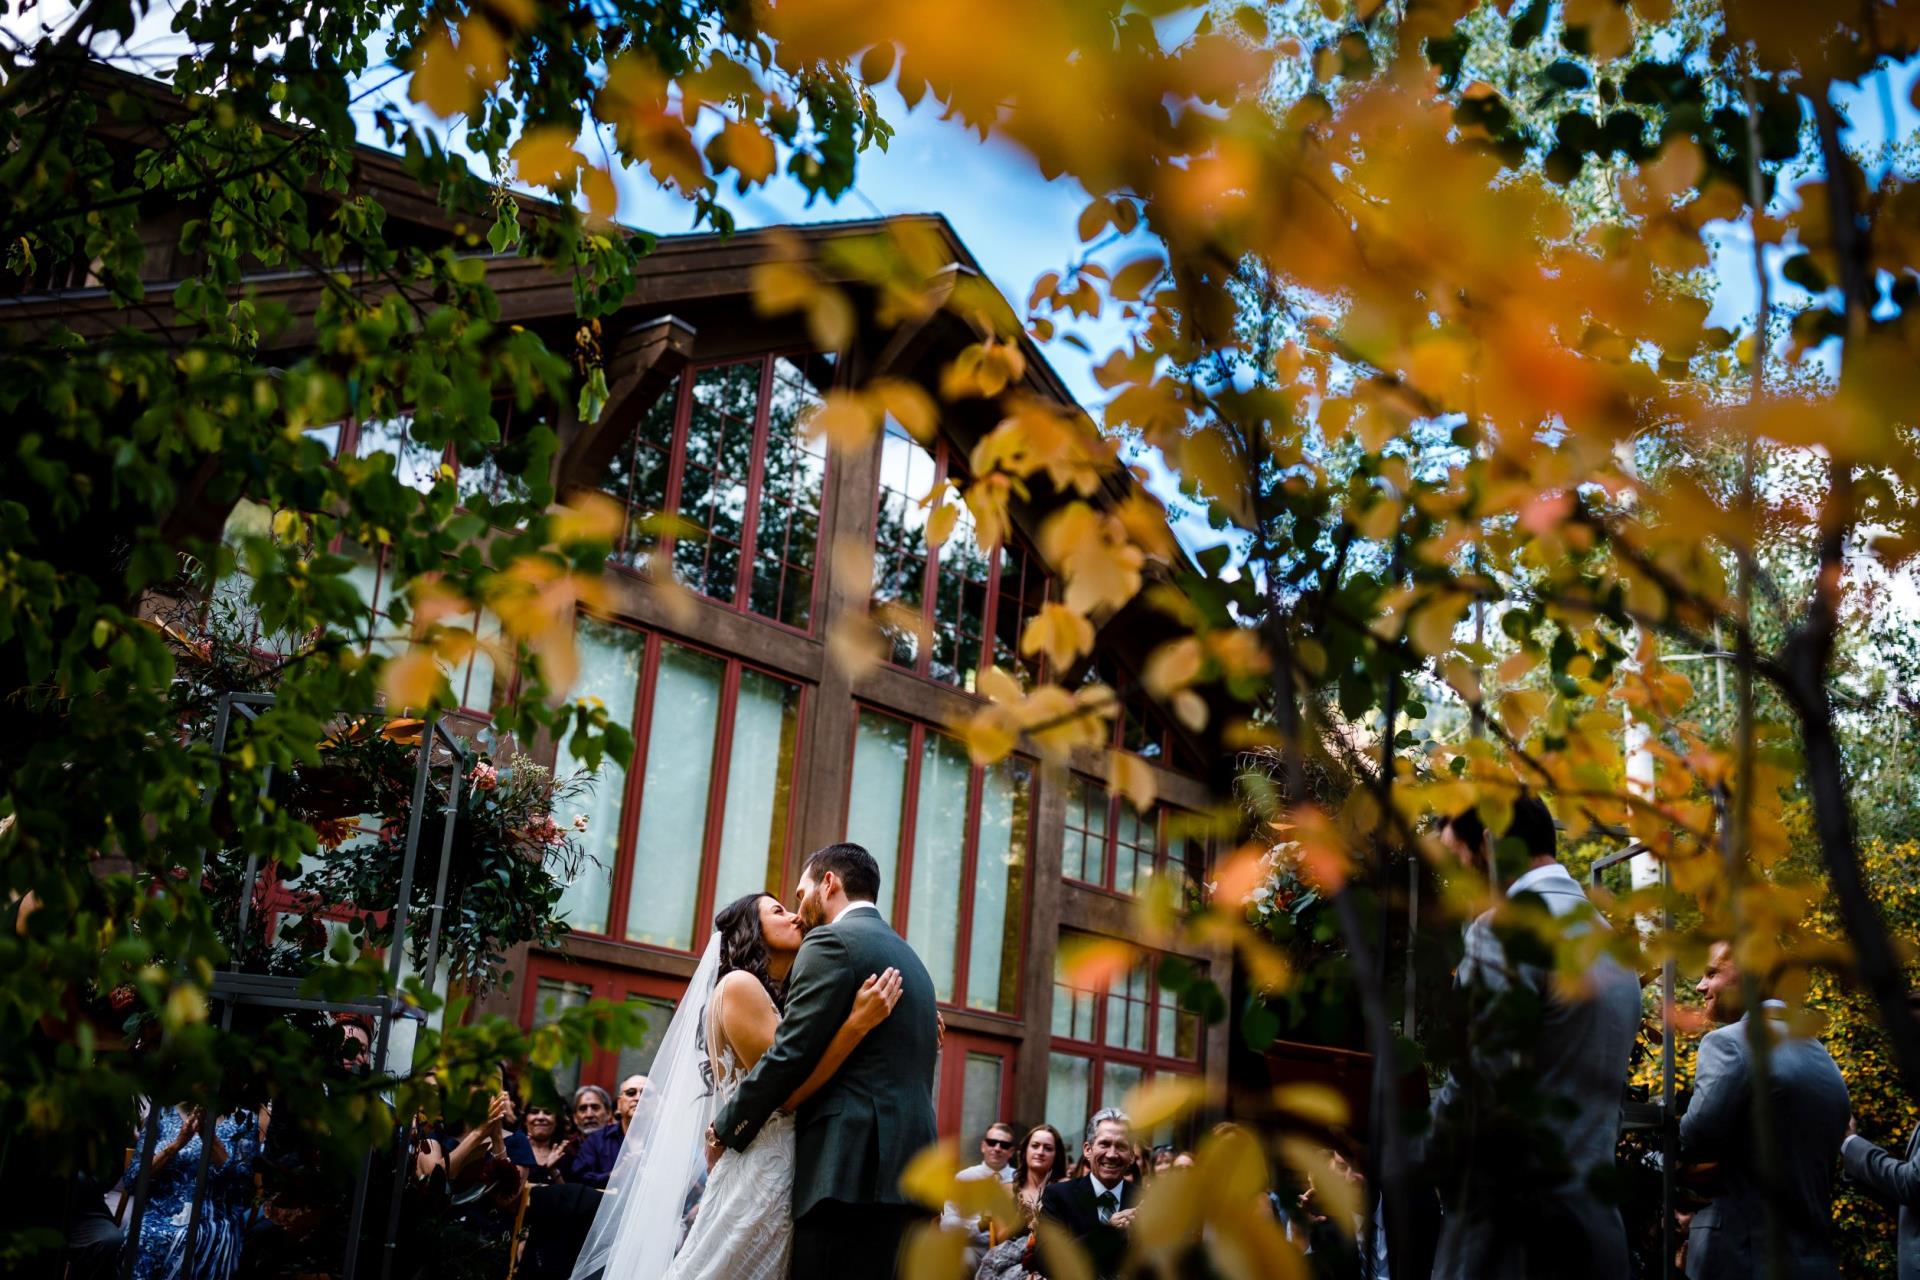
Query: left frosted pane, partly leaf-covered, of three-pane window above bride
557 618 647 933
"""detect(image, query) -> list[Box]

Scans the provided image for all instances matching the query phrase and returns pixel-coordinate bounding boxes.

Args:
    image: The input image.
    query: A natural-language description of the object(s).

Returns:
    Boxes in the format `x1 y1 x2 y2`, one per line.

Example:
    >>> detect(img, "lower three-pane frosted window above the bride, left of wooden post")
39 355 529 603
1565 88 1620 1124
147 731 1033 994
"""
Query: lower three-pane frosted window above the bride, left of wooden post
561 618 801 952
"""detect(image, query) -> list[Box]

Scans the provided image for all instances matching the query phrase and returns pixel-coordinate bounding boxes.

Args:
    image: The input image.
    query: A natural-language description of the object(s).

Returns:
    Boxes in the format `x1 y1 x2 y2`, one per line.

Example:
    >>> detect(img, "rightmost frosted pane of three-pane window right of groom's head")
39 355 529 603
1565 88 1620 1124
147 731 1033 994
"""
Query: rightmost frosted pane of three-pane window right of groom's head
966 758 1033 1013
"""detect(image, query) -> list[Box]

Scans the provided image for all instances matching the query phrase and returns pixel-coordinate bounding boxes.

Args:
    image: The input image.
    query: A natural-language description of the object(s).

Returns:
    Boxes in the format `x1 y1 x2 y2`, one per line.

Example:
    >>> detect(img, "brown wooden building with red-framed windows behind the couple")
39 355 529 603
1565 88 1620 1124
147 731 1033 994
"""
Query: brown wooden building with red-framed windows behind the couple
0 80 1227 1142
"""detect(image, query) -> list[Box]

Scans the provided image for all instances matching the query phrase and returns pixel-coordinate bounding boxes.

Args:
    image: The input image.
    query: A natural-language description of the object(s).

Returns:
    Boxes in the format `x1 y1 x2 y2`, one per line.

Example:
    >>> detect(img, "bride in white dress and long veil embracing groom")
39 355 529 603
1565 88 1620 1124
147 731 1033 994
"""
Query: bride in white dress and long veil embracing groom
572 894 900 1280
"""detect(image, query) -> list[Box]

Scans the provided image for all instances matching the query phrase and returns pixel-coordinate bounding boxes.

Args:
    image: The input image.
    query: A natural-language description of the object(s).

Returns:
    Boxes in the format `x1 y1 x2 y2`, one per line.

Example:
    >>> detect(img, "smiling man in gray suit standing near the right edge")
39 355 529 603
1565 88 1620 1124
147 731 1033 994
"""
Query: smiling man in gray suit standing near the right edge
1680 942 1849 1280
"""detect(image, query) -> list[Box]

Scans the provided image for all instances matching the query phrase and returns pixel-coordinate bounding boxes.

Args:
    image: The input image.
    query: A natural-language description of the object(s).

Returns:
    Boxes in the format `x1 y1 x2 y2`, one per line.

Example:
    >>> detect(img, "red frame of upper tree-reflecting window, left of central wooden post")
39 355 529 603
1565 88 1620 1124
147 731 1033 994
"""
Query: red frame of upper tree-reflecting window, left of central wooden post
609 347 833 635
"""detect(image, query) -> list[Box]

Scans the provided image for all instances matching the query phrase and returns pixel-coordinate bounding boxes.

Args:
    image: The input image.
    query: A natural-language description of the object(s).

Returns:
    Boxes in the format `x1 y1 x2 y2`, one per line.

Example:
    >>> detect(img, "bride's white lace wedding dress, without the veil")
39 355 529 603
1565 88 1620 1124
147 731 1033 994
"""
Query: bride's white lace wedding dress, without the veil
660 1029 793 1280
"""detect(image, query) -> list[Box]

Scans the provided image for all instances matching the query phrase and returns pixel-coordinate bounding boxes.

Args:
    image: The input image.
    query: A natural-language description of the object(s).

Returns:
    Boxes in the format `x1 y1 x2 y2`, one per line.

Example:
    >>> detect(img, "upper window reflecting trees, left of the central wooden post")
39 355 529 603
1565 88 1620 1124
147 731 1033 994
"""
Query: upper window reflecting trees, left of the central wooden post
597 355 833 631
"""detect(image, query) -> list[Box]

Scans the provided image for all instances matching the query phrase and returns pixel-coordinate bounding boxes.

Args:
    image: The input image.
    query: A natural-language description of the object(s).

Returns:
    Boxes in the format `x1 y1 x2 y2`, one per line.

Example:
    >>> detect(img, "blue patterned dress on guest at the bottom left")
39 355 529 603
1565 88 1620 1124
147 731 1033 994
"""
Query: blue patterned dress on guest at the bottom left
127 1107 259 1280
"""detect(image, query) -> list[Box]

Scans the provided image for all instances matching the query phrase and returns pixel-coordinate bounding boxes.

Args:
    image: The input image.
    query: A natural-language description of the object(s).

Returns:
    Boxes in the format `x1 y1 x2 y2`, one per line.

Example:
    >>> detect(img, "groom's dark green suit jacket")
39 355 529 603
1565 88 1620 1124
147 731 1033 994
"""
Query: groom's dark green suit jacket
714 908 939 1219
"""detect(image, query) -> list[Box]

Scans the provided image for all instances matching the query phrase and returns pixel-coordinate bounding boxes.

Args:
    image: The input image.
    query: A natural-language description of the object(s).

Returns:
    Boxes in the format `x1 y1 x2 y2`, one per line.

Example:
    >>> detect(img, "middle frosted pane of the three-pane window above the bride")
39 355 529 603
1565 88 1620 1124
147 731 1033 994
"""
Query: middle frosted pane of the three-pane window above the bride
626 645 726 952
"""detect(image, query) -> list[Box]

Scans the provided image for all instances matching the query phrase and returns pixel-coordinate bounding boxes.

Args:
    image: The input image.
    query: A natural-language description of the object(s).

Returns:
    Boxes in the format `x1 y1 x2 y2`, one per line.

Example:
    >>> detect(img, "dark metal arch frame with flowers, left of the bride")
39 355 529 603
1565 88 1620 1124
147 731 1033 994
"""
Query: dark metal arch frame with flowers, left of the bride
119 693 468 1280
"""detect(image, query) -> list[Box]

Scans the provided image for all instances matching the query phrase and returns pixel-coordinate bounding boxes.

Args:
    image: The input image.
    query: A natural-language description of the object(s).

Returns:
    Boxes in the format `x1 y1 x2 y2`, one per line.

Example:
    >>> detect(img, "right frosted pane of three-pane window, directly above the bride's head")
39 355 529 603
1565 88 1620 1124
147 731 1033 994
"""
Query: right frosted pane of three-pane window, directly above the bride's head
699 672 801 921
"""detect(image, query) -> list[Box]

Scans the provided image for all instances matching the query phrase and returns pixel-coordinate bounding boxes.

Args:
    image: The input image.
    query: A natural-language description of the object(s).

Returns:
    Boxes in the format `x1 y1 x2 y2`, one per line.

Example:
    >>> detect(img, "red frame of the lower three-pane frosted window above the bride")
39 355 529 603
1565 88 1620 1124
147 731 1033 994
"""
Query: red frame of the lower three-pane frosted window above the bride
572 620 812 956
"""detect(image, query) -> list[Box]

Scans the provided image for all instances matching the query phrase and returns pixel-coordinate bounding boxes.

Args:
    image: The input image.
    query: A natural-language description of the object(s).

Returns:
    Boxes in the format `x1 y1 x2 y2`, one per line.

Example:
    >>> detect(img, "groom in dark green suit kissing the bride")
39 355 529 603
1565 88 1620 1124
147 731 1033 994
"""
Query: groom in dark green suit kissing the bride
712 844 939 1280
